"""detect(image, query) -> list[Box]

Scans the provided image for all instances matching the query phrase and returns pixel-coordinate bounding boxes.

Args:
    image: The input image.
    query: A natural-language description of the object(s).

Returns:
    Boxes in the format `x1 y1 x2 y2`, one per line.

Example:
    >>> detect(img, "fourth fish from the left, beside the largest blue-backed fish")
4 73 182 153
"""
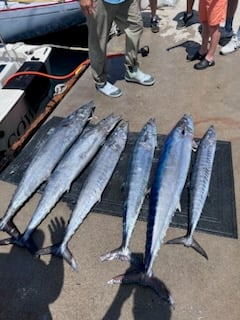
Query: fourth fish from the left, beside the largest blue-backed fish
101 119 157 261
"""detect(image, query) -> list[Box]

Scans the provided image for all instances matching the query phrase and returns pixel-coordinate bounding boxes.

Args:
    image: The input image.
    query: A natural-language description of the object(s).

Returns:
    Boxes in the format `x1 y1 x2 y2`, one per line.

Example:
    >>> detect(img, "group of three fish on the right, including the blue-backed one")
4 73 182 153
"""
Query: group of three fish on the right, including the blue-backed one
101 115 216 305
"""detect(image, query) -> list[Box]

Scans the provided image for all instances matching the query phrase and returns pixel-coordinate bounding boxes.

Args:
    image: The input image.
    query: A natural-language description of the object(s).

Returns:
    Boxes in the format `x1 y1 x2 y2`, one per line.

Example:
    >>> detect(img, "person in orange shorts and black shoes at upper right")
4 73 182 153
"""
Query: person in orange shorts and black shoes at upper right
191 0 227 70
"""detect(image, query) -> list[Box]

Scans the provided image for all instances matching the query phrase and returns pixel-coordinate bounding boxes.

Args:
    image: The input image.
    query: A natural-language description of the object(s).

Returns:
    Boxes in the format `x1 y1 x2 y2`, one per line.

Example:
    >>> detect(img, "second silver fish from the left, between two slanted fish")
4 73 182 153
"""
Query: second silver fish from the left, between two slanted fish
0 114 121 253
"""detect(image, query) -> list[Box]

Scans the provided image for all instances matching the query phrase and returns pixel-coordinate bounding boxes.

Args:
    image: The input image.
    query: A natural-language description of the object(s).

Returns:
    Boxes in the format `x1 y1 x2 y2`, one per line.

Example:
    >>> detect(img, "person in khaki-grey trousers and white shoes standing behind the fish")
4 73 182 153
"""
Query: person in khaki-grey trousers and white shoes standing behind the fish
80 0 155 98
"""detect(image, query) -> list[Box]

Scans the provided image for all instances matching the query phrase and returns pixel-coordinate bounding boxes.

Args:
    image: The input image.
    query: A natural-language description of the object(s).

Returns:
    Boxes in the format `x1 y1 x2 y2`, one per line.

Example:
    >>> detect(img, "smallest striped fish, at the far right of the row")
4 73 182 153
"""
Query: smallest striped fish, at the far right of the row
167 126 216 259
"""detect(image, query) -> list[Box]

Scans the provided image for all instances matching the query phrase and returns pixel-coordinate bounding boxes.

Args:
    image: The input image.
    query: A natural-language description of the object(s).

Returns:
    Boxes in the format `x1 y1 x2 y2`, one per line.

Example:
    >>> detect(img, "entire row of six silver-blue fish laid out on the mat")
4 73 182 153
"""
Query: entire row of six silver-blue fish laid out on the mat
0 102 216 305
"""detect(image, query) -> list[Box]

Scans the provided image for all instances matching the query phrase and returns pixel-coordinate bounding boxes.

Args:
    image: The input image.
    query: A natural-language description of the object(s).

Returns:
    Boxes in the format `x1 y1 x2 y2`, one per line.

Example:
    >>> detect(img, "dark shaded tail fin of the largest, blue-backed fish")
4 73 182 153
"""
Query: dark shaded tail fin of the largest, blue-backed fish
108 270 174 308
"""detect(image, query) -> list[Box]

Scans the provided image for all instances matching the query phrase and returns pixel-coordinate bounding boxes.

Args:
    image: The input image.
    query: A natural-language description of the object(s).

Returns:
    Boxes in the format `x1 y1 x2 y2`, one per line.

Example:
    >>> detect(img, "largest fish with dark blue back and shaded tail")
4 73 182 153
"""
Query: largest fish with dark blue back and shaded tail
109 115 194 305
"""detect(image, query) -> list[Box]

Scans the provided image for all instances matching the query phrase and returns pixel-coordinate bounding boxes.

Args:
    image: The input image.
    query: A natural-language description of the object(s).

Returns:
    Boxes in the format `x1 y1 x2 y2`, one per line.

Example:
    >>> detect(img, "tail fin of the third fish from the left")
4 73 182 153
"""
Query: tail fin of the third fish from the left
36 243 78 271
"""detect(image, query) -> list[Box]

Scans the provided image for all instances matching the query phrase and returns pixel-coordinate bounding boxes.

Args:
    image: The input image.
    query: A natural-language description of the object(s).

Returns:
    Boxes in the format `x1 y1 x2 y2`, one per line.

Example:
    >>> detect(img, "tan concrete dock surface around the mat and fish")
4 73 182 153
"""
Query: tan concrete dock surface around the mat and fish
0 0 240 320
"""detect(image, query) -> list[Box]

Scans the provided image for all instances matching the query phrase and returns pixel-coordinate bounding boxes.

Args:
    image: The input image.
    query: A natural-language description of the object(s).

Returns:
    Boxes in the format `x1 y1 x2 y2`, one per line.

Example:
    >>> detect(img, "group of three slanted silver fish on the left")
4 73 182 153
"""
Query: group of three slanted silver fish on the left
0 102 128 270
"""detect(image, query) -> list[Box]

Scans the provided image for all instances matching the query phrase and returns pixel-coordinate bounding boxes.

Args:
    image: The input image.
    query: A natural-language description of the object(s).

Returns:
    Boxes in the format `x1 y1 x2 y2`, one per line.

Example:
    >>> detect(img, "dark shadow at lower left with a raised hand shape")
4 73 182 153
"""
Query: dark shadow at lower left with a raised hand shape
0 220 65 320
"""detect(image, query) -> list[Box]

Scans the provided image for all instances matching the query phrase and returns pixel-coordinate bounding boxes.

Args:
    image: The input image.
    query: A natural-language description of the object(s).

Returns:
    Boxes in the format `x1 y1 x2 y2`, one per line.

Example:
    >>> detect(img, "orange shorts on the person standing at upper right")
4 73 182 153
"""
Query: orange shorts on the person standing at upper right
199 0 227 26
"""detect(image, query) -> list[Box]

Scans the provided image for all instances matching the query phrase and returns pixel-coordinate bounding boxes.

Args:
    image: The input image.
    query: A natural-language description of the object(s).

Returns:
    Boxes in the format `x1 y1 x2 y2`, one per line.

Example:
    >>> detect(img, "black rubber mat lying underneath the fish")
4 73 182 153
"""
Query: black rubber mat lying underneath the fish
0 117 238 238
